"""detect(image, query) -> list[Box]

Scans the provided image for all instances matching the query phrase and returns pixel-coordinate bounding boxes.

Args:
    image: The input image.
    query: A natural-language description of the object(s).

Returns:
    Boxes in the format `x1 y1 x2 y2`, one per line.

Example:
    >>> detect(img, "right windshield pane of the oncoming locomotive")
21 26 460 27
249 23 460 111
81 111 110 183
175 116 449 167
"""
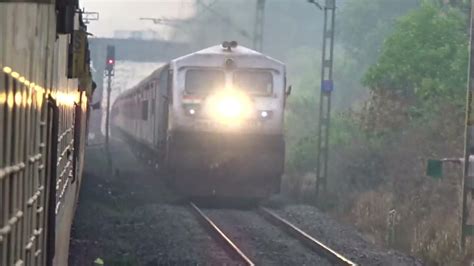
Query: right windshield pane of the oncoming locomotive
234 70 273 95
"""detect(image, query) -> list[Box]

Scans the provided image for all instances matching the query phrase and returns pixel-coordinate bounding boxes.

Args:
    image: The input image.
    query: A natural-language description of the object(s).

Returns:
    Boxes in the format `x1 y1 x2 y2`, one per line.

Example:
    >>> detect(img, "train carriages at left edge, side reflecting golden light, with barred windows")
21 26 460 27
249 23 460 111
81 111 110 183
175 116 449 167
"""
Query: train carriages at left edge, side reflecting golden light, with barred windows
0 0 93 266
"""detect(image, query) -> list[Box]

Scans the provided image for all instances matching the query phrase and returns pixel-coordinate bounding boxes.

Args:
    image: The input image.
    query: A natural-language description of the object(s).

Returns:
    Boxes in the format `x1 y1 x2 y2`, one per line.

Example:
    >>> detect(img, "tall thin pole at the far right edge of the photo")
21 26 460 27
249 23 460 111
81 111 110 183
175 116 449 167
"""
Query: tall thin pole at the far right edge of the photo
460 0 474 250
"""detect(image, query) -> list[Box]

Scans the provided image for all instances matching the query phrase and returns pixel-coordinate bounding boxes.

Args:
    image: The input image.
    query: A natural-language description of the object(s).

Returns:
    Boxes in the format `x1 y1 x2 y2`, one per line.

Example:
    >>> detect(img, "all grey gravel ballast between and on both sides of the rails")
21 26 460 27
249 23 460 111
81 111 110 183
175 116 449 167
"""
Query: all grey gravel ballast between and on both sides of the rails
69 139 421 266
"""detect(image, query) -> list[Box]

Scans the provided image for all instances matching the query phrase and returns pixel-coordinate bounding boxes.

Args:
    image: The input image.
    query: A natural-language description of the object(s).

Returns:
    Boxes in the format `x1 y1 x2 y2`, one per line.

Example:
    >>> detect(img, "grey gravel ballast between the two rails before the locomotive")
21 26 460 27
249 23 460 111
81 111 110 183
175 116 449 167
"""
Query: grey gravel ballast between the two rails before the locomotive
205 209 331 266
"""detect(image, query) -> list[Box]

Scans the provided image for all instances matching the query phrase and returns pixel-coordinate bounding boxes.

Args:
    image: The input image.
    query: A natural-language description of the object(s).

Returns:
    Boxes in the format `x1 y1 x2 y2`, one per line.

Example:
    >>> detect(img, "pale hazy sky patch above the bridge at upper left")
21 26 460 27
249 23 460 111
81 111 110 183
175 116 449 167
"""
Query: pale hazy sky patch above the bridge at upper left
80 0 195 38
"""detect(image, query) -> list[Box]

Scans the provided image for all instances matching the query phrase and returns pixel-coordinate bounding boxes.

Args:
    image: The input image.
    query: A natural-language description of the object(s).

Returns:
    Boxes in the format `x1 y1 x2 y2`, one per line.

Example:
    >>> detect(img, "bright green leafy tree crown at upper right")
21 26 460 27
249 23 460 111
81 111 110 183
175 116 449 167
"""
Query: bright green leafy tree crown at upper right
364 1 468 100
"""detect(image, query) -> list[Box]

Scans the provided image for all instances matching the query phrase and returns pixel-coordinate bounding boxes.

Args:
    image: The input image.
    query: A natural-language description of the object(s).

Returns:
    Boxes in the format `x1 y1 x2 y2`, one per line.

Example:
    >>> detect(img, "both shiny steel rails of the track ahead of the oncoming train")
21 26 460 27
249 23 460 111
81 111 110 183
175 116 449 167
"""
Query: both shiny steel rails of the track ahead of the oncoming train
190 202 357 265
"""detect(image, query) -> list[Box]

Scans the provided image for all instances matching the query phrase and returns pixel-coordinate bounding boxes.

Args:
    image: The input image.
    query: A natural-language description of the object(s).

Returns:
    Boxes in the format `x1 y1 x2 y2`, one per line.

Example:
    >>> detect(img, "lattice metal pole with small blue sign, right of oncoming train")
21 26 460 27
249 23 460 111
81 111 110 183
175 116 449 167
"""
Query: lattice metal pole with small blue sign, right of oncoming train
308 0 336 198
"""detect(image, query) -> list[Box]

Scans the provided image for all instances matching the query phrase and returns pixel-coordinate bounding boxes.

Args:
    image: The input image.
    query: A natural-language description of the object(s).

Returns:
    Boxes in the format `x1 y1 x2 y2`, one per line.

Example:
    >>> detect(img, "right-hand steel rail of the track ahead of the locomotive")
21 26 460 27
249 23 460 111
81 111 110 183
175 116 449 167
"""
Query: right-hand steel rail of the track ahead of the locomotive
259 207 357 266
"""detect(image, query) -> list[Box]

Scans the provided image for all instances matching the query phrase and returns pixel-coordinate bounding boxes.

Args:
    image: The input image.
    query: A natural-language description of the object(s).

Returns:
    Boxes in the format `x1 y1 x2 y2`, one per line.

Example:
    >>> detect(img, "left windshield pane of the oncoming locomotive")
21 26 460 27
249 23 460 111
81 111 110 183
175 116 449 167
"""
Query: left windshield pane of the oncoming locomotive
185 69 225 94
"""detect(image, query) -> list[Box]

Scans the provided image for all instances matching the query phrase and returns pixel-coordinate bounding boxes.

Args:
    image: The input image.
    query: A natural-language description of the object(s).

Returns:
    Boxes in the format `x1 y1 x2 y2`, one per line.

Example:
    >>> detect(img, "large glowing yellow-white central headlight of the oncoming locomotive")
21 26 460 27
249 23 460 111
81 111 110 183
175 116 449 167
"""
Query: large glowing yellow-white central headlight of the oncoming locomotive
208 89 252 124
